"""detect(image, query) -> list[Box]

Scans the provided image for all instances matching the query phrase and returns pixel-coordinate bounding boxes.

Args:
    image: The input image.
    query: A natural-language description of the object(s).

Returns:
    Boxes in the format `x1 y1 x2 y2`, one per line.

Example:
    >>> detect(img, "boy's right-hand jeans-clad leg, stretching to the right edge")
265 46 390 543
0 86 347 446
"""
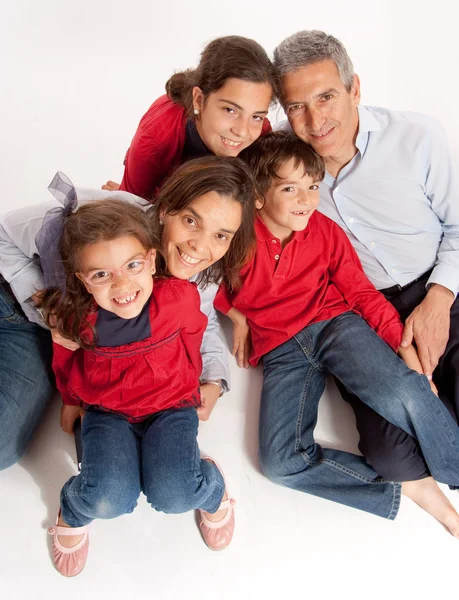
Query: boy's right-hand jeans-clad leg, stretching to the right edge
319 312 459 485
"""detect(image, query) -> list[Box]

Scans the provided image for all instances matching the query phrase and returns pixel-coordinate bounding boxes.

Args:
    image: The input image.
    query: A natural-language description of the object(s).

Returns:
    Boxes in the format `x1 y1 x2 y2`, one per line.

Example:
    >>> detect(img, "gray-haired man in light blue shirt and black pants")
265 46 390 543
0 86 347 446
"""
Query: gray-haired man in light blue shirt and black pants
274 31 459 488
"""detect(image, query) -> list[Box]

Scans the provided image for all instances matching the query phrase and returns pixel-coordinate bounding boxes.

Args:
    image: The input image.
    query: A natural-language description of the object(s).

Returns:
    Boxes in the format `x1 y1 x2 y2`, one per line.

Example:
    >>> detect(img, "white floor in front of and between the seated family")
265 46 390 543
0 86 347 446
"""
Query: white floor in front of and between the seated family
0 324 459 600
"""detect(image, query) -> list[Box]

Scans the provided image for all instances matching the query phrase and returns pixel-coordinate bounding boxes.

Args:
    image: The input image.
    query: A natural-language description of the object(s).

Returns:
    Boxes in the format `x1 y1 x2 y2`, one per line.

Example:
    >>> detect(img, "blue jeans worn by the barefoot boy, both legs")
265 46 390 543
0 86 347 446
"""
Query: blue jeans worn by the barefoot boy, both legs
260 312 459 519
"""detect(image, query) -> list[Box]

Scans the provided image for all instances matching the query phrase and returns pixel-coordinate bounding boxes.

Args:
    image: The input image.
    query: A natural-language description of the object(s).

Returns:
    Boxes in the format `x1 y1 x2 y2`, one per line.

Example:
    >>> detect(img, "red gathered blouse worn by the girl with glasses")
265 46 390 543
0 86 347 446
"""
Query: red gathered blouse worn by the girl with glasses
53 279 207 421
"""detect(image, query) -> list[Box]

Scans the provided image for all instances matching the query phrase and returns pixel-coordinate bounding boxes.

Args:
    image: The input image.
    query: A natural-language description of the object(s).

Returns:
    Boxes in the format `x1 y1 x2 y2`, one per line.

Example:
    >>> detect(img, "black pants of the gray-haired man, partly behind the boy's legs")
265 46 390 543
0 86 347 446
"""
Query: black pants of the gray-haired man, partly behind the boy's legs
337 272 459 481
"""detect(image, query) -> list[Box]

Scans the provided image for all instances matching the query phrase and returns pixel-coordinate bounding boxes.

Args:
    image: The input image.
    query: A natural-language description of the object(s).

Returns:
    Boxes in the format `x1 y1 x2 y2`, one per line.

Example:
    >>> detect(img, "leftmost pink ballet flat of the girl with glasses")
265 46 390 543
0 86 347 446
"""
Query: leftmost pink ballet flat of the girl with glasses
48 516 89 577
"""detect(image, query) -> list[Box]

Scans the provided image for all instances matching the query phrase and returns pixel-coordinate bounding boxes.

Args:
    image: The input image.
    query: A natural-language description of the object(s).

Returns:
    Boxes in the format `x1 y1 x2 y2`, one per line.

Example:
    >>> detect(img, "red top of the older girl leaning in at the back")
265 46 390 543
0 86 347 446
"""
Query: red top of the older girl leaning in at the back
120 95 271 200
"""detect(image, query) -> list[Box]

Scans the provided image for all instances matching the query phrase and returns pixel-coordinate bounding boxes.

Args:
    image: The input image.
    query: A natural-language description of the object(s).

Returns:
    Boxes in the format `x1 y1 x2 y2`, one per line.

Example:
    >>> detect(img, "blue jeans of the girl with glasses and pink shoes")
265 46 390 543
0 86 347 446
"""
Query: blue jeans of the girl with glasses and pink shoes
61 408 225 527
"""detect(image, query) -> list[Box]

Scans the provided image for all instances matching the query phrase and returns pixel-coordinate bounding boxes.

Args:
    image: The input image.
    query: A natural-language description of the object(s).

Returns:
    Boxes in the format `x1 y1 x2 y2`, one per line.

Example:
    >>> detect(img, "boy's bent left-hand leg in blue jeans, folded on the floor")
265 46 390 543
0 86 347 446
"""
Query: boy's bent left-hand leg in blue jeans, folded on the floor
259 332 400 519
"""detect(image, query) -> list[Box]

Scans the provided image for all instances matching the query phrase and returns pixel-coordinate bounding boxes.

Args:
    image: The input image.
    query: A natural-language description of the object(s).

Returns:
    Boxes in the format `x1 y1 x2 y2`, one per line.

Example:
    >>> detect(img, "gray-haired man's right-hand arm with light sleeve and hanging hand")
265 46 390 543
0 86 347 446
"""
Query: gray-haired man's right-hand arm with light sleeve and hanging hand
402 120 459 378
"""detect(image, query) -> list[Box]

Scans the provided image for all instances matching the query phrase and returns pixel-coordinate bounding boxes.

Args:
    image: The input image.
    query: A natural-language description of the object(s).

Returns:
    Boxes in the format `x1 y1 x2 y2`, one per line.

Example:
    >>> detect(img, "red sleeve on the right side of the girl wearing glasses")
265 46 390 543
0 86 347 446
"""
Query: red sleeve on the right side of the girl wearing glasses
173 280 207 377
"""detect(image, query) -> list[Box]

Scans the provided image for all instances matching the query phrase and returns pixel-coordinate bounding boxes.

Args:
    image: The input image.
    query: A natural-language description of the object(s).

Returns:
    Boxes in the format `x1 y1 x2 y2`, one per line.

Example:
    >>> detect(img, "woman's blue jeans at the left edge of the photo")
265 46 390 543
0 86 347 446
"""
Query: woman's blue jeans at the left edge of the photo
0 277 54 469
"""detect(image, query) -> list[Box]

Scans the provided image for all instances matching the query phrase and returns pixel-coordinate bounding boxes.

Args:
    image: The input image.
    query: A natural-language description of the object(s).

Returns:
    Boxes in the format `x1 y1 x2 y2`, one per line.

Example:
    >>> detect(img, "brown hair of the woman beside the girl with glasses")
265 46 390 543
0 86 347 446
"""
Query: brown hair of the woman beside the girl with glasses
149 156 260 289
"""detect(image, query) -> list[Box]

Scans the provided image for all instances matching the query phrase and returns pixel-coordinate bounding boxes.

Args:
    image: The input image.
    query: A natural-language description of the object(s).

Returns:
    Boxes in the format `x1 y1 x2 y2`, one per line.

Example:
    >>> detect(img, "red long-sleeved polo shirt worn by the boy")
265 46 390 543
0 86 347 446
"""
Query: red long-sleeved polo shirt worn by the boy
214 212 403 366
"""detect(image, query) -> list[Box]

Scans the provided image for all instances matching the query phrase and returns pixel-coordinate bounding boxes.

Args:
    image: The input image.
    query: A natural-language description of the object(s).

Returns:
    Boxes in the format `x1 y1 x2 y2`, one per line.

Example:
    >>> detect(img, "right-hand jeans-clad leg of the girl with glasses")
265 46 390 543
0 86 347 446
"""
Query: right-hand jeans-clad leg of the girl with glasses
142 408 225 513
